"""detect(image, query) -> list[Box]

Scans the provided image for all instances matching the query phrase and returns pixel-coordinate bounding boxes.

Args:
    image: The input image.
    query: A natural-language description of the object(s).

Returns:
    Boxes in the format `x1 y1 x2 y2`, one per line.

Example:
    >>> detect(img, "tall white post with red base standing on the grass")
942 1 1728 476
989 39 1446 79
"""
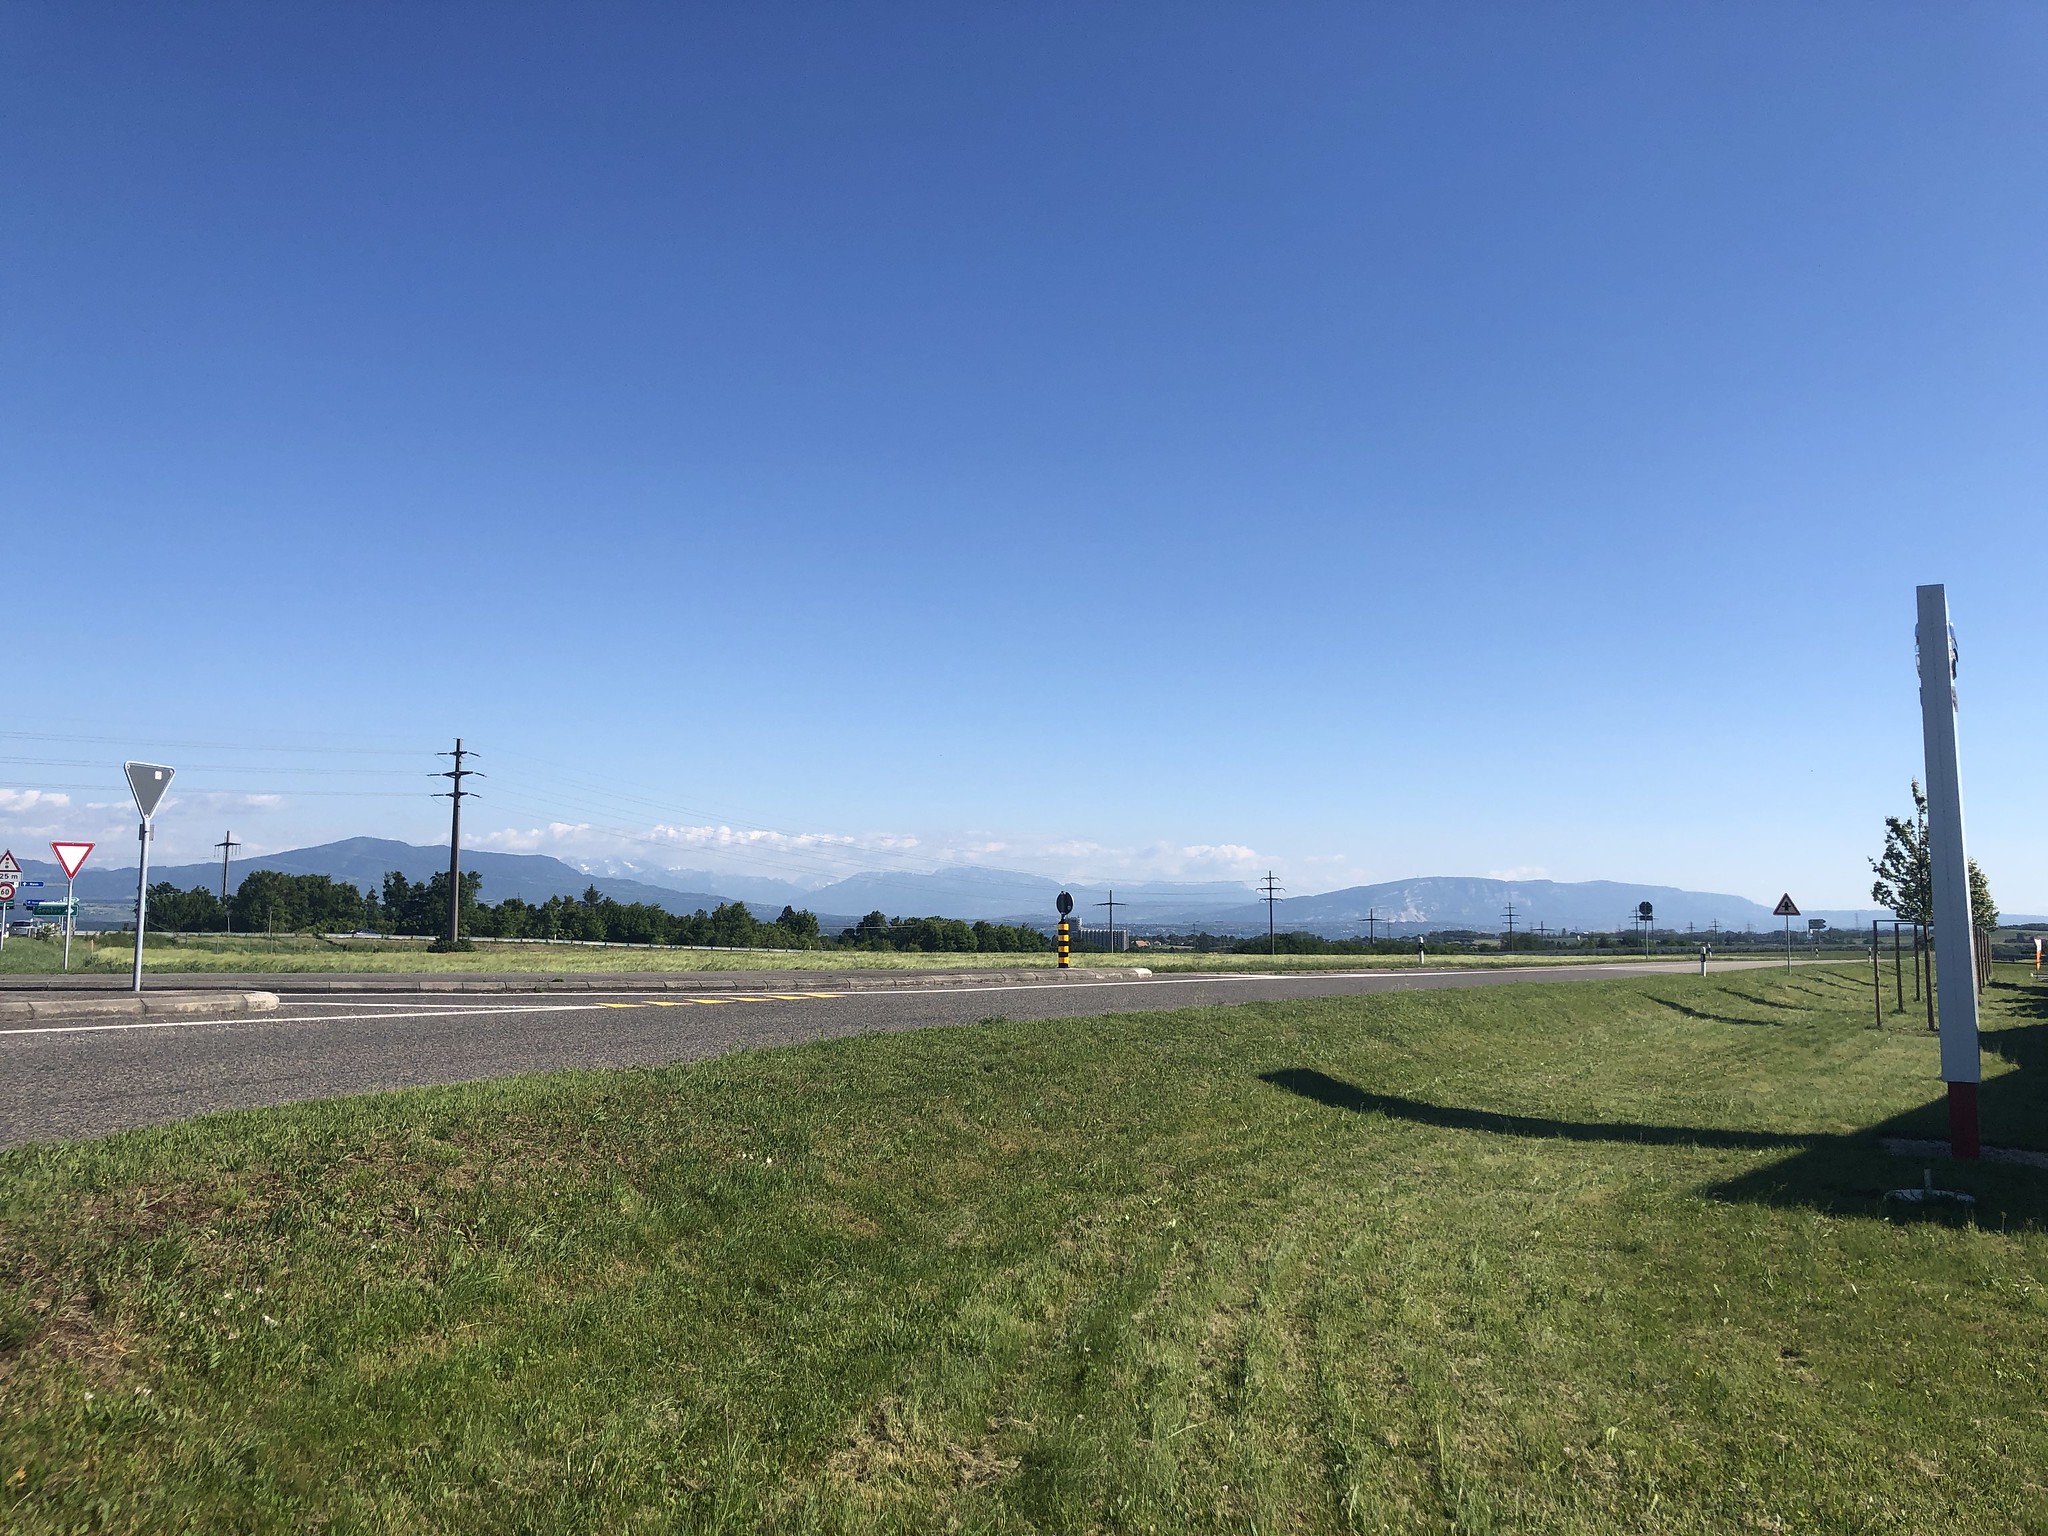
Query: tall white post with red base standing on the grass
1915 584 1982 1157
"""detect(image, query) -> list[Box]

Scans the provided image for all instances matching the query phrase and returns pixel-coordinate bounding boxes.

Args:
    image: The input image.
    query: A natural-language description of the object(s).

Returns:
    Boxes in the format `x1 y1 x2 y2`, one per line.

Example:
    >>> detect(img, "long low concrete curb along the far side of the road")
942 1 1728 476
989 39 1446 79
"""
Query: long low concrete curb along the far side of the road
0 967 1151 1003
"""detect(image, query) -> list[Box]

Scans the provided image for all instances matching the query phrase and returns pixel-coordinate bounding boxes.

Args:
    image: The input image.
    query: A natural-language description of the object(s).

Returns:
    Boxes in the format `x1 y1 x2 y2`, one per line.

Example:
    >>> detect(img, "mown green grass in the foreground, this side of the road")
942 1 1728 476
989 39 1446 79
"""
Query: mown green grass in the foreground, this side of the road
0 971 2048 1532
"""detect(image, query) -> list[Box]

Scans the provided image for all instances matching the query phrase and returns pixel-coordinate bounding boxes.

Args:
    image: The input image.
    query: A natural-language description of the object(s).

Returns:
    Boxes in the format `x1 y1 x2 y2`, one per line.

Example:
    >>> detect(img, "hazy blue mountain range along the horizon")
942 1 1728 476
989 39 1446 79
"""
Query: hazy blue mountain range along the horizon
4 838 1998 938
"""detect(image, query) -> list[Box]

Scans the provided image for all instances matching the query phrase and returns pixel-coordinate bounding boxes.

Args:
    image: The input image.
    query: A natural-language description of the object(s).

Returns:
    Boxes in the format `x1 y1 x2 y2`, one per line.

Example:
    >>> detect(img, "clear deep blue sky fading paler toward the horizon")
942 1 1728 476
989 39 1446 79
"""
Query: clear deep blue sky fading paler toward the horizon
0 0 2048 911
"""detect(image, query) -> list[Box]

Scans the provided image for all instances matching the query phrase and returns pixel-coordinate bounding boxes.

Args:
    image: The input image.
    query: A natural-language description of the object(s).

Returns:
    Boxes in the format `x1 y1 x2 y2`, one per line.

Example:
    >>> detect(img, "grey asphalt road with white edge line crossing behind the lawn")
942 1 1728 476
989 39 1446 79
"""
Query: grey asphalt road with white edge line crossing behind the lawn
0 961 1769 1145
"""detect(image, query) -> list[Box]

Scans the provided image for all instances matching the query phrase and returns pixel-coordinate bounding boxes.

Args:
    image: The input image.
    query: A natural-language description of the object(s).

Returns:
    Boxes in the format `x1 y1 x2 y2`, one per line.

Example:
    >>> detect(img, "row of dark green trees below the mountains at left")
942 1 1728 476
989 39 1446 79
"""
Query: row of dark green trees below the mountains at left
150 870 1053 952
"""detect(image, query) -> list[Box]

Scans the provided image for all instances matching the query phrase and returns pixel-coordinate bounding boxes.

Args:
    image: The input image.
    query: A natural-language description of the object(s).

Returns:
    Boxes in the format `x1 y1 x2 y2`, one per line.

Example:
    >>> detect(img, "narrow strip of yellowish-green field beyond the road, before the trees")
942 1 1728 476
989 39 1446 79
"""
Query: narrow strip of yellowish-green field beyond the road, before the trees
0 934 1804 977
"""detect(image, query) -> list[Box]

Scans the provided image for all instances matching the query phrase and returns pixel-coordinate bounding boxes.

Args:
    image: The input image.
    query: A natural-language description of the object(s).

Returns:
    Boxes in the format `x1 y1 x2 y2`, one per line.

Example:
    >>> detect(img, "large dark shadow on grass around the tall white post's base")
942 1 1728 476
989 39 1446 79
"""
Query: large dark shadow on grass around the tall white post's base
1262 1048 2048 1229
